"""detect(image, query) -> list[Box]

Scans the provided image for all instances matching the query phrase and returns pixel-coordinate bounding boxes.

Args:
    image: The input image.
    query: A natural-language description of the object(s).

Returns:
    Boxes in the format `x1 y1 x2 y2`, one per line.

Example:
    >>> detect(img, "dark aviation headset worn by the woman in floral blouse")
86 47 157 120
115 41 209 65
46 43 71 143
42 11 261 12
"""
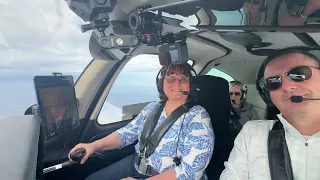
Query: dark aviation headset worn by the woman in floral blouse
156 63 198 101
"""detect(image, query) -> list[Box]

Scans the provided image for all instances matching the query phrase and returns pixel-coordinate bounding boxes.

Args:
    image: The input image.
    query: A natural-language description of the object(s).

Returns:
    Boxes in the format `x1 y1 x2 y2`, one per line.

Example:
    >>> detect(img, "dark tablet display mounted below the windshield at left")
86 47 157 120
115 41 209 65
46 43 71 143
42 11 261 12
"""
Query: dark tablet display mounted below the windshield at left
34 76 80 140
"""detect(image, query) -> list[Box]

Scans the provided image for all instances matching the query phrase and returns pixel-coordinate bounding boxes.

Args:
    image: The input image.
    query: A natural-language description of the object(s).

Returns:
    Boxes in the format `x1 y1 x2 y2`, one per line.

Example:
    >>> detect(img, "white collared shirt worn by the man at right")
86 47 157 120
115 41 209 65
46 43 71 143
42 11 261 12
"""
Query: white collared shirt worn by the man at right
220 114 320 180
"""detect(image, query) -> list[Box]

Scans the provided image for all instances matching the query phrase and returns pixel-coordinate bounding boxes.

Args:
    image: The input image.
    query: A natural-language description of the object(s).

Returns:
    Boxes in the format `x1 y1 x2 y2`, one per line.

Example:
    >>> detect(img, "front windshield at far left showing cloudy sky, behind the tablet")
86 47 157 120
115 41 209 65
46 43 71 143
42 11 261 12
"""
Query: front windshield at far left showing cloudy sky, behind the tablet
0 0 92 119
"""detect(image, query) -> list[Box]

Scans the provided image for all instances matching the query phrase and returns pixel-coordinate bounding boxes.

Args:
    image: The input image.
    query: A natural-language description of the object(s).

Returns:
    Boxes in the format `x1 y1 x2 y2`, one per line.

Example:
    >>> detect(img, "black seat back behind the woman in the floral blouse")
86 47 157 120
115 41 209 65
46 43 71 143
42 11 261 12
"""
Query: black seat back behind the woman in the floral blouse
197 75 236 180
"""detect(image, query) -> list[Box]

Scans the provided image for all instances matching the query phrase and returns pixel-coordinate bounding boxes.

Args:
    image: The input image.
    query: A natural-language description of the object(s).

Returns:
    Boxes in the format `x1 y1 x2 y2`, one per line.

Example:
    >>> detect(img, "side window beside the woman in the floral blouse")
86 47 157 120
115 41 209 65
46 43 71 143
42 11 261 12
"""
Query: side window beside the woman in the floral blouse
98 54 161 125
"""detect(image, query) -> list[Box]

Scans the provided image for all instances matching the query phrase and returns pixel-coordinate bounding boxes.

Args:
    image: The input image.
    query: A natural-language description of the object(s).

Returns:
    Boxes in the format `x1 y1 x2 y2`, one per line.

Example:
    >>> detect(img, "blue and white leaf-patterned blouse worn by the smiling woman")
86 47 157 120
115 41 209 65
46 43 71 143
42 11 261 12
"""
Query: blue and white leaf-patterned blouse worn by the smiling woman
116 102 214 180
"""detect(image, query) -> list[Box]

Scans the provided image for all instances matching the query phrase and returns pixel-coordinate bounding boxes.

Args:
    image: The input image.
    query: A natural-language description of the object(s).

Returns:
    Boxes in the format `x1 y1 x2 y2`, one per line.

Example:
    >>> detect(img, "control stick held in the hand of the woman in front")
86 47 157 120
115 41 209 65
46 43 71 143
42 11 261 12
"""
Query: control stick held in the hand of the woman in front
43 148 86 174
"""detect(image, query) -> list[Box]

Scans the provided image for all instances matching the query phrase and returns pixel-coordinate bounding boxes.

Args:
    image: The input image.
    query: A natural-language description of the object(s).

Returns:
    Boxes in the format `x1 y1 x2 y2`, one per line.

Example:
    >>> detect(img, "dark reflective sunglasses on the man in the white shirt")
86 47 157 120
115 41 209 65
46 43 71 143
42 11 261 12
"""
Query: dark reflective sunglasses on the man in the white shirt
264 66 319 91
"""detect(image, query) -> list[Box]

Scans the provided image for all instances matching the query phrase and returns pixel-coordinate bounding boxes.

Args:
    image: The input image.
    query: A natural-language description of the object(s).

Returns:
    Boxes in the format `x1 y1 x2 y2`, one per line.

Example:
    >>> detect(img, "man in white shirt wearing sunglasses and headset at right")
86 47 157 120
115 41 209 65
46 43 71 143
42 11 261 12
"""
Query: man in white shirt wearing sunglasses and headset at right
220 47 320 180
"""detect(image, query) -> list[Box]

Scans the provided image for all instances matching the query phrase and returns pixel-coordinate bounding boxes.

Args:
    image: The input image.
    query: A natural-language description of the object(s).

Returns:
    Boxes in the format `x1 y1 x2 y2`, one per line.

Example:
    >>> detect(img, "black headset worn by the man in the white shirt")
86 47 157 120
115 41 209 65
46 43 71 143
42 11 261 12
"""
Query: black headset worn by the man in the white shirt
256 46 320 107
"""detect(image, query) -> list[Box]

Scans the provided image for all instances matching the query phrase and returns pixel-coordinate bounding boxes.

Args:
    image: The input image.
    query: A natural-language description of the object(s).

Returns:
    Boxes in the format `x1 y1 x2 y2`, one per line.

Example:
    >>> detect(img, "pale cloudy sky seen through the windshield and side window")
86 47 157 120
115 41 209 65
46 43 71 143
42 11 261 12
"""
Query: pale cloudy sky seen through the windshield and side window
0 0 234 123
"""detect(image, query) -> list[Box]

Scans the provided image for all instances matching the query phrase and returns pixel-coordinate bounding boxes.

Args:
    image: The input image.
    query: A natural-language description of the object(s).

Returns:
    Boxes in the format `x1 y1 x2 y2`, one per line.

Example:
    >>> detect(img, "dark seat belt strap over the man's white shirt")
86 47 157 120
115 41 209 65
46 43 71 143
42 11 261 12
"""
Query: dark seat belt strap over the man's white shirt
268 120 293 180
